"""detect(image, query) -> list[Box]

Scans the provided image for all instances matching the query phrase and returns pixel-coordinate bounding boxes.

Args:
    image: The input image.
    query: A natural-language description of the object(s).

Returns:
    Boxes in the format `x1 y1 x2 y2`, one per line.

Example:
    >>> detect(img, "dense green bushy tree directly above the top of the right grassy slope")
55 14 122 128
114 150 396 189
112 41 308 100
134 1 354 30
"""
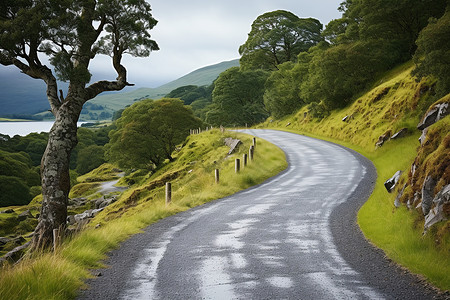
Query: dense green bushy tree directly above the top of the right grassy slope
301 40 398 109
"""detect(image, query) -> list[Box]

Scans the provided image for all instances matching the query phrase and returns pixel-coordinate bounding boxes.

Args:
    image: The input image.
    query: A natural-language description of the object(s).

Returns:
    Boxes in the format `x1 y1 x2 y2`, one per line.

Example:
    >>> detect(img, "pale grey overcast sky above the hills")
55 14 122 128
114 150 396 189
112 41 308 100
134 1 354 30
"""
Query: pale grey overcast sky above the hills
91 0 342 87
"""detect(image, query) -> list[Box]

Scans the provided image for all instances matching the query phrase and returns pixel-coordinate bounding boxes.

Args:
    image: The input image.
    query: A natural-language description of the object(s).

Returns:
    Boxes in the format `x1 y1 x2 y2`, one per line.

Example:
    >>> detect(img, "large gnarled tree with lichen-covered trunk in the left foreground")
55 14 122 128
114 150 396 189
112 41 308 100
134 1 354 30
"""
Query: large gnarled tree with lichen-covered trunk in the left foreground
0 0 158 249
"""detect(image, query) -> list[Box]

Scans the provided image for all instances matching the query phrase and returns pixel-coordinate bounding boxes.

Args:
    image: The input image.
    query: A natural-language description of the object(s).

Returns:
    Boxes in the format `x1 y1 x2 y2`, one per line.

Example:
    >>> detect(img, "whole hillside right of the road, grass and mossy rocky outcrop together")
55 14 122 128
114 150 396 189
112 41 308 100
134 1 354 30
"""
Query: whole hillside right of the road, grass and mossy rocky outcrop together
258 63 450 290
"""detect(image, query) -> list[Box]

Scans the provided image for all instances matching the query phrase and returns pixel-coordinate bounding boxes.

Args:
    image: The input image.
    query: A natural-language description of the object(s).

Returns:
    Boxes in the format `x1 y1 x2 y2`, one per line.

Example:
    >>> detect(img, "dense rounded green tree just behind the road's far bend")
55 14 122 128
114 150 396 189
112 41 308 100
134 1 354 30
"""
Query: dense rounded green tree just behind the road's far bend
206 67 269 126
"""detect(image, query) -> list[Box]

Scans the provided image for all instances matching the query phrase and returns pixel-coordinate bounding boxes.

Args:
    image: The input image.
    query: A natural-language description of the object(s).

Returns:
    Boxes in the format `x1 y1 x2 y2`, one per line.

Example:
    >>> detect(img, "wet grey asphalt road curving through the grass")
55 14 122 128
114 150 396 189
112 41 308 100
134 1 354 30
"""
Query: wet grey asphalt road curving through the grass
79 130 448 300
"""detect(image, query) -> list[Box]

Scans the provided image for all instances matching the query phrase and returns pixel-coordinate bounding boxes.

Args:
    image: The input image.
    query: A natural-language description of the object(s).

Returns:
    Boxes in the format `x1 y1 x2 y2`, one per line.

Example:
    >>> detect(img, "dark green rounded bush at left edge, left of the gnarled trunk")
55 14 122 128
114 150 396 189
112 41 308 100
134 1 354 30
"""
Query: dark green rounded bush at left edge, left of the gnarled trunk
0 175 32 207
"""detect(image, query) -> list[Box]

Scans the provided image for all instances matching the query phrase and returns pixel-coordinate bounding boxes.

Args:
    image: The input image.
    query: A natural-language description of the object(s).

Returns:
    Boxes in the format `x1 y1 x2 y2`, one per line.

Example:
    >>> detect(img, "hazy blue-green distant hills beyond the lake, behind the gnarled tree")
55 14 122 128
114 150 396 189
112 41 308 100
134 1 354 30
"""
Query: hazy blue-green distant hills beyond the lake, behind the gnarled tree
0 59 239 121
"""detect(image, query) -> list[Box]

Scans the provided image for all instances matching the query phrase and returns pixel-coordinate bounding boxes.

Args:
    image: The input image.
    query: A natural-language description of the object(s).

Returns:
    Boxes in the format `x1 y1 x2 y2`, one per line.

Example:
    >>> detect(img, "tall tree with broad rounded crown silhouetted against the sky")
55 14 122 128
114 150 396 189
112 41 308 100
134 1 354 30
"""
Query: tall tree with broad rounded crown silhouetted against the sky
239 10 322 70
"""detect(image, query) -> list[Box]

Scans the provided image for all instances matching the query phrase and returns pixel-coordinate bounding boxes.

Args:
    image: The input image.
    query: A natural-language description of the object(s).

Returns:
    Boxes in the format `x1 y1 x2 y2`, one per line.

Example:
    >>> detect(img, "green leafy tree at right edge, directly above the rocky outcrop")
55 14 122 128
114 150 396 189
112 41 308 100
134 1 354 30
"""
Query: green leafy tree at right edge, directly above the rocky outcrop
414 5 450 97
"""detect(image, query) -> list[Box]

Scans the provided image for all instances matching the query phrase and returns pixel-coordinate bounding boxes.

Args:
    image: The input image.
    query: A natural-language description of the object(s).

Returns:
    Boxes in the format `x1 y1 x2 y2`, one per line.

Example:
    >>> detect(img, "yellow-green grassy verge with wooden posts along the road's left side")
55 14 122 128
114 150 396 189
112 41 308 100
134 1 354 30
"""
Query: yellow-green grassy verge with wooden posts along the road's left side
0 130 287 299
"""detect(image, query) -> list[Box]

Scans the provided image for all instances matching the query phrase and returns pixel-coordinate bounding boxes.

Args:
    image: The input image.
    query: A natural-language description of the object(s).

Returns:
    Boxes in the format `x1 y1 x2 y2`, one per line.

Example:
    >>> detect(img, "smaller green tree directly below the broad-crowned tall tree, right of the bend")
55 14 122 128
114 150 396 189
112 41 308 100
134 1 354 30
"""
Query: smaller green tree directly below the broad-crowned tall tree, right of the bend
264 62 308 118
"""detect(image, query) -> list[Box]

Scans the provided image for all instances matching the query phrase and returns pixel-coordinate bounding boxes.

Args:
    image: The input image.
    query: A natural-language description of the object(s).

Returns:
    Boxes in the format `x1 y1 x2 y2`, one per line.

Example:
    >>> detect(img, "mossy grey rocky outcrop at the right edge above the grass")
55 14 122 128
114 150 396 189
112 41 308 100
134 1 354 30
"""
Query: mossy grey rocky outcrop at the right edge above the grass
394 97 450 236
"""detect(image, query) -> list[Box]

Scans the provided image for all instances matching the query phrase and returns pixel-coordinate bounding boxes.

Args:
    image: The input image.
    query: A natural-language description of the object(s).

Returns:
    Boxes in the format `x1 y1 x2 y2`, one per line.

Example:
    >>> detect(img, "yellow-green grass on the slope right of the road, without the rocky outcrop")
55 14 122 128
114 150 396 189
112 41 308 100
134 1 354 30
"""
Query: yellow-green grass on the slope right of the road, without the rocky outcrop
258 64 450 290
